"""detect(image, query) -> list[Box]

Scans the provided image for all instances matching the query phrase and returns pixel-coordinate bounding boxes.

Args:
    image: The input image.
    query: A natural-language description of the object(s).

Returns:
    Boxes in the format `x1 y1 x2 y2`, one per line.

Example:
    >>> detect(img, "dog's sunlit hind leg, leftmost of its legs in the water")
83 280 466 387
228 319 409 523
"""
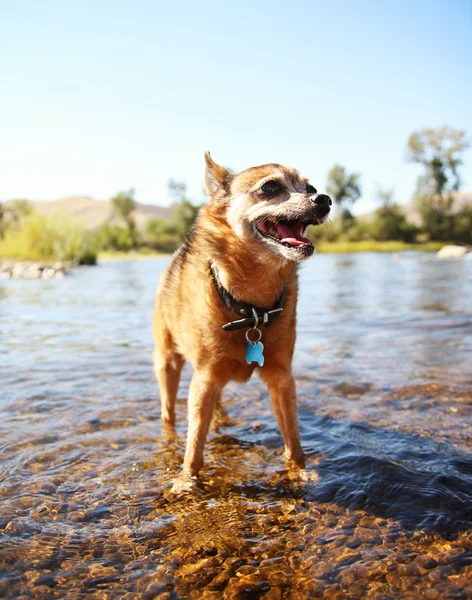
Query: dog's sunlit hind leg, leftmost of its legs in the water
154 332 185 427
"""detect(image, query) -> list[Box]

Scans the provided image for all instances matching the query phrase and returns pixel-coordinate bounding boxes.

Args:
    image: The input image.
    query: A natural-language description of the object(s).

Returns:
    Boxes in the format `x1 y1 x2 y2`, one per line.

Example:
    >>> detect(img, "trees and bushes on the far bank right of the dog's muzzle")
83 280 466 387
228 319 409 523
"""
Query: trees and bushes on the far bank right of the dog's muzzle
311 127 472 252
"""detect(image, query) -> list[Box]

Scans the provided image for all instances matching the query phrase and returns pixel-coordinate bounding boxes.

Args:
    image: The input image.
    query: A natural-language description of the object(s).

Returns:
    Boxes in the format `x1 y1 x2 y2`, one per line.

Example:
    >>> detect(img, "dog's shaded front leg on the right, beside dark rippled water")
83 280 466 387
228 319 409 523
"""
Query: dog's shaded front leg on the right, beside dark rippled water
261 368 305 469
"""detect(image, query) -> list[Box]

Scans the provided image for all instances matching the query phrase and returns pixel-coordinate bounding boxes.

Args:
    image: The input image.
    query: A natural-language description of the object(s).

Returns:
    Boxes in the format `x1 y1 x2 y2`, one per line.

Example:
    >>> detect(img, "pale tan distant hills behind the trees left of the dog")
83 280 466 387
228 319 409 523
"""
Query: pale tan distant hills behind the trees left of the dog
6 196 174 229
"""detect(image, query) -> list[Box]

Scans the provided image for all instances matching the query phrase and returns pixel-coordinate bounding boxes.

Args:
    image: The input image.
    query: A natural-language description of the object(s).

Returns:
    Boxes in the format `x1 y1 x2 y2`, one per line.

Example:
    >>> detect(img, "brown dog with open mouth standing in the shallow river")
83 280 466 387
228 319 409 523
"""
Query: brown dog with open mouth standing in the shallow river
153 152 331 476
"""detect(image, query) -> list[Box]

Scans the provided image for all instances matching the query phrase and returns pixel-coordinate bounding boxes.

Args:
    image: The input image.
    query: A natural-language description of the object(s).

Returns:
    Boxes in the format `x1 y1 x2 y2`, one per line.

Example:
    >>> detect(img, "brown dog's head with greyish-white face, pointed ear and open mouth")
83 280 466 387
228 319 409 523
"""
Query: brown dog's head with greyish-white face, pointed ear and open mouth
205 152 332 261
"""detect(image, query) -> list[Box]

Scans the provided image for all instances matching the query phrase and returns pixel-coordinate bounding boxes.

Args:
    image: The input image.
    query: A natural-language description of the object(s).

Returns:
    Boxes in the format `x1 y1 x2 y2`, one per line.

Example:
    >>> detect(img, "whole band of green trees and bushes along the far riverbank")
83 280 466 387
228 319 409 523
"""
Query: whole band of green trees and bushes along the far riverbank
0 126 472 264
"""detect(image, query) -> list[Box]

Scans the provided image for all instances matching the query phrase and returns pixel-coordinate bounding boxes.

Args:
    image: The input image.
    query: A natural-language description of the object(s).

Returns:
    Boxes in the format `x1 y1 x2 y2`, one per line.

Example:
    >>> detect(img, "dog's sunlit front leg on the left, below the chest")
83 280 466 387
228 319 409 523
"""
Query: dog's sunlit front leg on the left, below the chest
184 371 221 476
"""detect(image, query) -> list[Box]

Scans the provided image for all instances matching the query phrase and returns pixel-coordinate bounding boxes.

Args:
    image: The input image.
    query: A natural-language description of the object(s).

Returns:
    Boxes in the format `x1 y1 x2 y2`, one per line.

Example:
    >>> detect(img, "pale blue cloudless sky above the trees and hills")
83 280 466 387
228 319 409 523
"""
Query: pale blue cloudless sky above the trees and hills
0 0 472 214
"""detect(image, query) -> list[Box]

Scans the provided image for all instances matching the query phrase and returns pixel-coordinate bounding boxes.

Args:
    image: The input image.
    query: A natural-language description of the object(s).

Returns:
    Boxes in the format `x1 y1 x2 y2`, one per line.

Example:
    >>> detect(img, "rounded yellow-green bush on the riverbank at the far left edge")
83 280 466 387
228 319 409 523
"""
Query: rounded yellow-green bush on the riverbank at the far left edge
0 212 97 264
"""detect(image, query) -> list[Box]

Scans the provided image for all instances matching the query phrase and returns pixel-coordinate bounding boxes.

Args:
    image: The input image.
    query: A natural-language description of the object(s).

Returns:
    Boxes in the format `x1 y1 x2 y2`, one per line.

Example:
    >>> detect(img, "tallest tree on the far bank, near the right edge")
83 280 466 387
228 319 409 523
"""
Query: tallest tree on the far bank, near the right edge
406 125 469 240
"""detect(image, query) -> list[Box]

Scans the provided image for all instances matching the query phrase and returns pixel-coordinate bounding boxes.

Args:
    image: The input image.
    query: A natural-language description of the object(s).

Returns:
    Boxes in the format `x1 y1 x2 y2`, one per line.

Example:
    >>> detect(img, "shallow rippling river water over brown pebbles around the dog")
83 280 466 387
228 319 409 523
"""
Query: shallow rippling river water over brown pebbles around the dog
0 254 472 600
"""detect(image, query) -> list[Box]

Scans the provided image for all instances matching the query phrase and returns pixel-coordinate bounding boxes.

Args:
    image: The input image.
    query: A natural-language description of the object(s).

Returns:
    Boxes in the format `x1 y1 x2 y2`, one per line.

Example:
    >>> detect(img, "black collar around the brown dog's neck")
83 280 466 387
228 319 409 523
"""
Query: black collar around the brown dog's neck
210 263 285 331
